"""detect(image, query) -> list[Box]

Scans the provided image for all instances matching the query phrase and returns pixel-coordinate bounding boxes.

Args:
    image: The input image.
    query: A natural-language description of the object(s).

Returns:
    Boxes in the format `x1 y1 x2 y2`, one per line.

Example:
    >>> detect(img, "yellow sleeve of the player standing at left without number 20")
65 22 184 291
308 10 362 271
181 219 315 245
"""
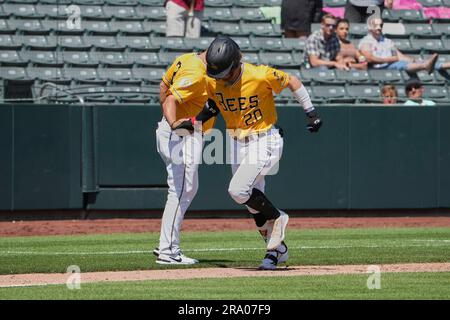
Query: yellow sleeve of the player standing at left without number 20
170 75 206 103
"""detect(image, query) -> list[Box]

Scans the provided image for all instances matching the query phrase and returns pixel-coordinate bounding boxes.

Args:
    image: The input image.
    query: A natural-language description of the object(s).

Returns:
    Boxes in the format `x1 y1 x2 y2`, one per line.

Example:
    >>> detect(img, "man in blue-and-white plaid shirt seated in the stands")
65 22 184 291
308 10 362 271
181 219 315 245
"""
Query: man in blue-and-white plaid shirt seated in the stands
304 14 350 70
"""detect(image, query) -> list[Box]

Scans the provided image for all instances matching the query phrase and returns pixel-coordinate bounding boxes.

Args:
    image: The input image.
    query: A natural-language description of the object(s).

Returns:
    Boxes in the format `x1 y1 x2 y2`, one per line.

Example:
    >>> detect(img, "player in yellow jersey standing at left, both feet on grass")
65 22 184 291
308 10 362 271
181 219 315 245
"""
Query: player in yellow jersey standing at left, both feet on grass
153 53 214 264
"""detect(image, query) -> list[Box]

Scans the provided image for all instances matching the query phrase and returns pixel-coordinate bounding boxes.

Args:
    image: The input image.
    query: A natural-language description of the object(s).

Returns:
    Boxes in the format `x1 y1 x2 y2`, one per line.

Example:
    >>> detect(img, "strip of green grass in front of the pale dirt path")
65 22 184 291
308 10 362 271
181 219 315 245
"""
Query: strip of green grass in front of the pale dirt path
0 272 450 300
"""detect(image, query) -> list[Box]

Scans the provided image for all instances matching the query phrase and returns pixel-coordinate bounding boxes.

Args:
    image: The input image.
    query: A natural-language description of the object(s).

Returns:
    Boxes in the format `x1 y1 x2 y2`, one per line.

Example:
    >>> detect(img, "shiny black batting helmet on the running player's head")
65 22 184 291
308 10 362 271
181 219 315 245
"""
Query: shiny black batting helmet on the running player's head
206 36 241 79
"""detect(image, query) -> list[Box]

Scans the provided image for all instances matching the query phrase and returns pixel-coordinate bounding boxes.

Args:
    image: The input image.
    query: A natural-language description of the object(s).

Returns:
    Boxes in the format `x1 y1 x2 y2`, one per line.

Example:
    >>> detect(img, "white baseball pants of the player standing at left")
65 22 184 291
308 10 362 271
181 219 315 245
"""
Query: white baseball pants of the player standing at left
156 118 203 255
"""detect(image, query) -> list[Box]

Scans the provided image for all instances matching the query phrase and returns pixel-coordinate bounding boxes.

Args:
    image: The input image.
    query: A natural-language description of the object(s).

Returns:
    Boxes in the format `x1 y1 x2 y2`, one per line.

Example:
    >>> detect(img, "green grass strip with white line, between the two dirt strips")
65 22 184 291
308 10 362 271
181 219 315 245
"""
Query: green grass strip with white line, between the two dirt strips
0 228 450 274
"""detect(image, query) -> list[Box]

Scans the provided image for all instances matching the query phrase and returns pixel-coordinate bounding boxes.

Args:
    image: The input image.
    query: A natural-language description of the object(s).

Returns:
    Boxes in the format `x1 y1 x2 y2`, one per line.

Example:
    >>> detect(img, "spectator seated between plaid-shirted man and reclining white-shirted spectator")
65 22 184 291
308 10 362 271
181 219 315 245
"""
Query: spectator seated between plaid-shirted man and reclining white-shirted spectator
336 19 367 70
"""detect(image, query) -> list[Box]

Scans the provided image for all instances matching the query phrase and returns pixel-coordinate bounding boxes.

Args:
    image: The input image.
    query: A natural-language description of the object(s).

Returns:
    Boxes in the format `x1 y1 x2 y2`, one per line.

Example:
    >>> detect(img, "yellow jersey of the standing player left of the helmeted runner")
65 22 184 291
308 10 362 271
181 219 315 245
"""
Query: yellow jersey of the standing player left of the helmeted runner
162 53 215 131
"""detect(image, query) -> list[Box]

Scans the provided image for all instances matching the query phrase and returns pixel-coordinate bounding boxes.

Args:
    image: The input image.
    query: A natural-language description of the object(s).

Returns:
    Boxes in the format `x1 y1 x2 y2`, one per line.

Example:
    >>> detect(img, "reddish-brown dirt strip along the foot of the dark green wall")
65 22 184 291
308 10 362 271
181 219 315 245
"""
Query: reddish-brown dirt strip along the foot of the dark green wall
0 217 450 237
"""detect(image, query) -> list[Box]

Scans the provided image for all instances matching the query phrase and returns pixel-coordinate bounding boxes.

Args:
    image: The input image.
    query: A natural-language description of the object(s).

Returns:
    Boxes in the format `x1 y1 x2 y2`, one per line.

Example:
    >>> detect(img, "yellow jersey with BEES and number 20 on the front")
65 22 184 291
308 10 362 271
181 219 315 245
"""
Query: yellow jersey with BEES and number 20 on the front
206 63 289 138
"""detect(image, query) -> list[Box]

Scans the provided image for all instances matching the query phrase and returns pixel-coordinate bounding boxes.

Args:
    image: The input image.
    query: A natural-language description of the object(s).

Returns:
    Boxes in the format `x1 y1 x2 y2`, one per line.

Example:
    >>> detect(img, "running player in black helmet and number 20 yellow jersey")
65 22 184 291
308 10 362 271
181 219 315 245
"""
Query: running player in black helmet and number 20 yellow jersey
173 36 322 270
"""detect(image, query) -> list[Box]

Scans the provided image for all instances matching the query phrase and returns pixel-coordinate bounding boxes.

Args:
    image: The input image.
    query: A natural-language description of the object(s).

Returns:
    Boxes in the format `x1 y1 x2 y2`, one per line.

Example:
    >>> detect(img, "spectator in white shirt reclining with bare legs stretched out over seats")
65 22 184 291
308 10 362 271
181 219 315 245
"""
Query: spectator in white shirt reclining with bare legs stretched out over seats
358 18 444 73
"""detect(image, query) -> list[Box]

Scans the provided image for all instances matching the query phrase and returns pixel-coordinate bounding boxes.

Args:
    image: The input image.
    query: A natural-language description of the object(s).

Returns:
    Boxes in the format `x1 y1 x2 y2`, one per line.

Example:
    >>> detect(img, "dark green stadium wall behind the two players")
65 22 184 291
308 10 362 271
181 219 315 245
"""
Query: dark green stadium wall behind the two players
0 104 450 211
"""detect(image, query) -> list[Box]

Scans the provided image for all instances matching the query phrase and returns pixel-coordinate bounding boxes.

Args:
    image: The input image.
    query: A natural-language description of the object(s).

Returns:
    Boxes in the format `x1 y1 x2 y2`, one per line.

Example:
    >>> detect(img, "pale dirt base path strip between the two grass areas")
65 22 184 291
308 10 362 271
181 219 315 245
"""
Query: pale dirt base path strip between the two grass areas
0 263 450 288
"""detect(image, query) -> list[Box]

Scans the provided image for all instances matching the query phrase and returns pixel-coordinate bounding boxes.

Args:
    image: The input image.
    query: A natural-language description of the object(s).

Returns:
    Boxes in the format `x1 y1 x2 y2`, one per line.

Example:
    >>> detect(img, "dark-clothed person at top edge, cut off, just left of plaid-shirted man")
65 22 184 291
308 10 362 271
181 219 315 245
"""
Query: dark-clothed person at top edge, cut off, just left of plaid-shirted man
281 0 323 39
